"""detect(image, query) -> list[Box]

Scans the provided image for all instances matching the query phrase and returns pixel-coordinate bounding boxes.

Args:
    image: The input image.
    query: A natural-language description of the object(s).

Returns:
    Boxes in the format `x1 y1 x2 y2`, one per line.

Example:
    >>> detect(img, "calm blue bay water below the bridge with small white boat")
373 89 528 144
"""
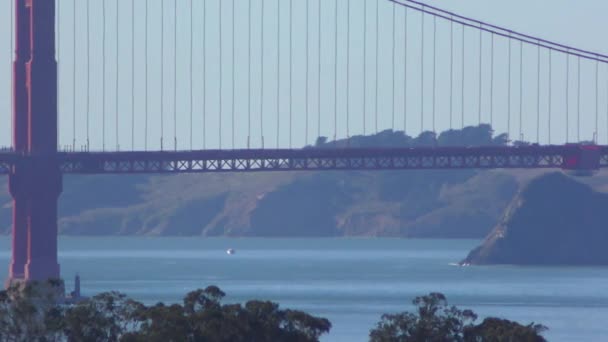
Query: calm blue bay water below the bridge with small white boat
0 236 608 341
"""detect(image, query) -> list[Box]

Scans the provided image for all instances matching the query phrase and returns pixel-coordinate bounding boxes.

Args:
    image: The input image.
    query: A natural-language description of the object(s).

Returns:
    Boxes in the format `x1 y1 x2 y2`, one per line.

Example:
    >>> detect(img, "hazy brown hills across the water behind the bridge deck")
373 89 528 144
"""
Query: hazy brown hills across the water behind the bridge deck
0 125 518 239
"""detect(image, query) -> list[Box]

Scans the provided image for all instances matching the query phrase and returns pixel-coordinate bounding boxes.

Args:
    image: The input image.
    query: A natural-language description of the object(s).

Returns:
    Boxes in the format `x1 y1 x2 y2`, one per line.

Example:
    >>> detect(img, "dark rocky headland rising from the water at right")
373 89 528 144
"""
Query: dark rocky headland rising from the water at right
463 173 608 265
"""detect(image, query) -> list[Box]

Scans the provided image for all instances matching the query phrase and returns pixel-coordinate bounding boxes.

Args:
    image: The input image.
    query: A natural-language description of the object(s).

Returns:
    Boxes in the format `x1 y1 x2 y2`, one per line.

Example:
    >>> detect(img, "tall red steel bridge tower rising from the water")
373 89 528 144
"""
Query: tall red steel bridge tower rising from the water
7 0 62 285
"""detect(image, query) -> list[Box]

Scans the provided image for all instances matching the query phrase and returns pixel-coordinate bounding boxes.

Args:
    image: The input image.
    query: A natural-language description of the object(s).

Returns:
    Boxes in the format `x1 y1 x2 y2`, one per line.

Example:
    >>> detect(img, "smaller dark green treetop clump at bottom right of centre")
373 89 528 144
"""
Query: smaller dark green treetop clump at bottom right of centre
370 293 546 342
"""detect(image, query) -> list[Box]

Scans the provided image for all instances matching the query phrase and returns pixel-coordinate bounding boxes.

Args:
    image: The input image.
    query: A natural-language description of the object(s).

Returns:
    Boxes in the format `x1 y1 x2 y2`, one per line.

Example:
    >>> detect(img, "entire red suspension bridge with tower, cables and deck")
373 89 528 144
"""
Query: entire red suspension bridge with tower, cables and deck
0 0 608 284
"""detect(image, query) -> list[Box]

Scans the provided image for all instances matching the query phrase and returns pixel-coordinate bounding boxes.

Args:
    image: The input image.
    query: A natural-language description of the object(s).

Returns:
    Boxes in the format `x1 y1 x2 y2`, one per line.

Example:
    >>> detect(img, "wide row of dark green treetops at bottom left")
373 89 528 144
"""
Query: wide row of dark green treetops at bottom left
0 286 331 342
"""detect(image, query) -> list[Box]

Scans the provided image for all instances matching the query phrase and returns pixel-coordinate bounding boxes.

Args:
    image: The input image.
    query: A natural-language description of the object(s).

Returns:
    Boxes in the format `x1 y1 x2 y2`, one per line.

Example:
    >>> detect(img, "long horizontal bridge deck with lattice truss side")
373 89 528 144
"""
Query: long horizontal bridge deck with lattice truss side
0 145 608 174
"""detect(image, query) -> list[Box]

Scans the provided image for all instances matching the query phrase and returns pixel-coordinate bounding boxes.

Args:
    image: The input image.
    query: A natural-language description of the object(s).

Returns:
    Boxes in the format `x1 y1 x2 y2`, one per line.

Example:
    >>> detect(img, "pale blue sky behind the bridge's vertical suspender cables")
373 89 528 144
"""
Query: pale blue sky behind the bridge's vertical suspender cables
0 0 608 150
